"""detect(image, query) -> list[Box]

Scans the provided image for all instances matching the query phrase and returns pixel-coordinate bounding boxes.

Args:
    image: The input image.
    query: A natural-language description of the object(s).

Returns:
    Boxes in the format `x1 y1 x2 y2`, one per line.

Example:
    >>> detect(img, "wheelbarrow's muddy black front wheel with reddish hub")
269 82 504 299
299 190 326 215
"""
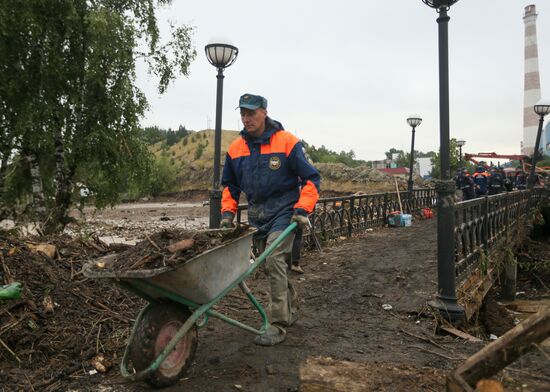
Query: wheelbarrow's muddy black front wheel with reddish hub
128 302 198 388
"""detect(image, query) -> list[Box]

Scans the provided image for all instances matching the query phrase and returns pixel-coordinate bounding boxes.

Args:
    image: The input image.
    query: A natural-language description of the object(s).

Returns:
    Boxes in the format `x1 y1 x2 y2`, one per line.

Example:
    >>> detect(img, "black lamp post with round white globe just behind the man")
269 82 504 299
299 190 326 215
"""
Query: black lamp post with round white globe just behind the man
204 39 239 229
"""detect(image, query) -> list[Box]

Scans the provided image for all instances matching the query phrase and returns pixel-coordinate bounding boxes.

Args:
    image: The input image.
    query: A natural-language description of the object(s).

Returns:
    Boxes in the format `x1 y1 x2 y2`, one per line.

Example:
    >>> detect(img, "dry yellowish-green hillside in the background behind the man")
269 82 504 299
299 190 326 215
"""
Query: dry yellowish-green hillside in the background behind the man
150 129 404 195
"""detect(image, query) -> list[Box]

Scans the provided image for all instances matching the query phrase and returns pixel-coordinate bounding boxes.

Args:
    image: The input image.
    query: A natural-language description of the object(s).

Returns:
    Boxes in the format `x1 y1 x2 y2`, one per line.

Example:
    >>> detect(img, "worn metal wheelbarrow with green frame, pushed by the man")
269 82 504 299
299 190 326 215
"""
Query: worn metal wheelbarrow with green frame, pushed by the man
83 223 297 388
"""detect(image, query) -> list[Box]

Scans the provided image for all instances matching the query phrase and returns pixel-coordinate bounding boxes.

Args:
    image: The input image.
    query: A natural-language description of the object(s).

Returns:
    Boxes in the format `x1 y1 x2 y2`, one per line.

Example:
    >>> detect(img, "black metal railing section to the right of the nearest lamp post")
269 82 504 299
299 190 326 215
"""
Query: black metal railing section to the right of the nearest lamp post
454 188 550 284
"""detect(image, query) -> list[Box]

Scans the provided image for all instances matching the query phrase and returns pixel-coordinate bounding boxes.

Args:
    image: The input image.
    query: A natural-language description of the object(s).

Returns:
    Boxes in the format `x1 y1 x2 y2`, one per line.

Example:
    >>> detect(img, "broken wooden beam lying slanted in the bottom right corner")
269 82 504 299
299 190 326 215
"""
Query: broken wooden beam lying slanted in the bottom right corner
447 308 550 392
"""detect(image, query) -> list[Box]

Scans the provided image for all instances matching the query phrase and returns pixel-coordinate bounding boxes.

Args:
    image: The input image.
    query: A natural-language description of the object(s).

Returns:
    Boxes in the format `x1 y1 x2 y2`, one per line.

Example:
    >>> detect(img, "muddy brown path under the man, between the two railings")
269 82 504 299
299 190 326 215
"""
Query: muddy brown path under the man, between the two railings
91 220 492 392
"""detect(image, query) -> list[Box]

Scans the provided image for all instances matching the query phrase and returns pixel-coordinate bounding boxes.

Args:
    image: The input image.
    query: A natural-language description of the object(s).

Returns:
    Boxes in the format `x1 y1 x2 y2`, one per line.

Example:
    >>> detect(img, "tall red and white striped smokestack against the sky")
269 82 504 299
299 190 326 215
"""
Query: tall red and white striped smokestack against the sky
521 4 540 155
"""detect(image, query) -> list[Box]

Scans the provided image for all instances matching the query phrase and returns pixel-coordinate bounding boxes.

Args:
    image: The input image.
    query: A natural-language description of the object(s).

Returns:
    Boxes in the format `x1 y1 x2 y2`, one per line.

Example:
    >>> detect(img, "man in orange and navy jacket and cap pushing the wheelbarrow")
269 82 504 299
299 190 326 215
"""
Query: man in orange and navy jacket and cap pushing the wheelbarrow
221 94 321 346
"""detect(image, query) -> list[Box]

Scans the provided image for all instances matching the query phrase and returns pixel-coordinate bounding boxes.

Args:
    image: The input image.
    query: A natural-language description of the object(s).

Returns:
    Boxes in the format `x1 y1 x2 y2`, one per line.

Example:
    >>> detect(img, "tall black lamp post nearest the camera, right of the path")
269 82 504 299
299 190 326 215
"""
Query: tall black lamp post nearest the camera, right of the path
422 0 464 322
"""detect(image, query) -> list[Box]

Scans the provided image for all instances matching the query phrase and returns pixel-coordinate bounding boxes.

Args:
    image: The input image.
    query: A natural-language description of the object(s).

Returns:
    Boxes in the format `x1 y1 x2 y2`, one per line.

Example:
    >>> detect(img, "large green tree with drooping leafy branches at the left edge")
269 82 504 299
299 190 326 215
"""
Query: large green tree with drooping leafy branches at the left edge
0 0 196 230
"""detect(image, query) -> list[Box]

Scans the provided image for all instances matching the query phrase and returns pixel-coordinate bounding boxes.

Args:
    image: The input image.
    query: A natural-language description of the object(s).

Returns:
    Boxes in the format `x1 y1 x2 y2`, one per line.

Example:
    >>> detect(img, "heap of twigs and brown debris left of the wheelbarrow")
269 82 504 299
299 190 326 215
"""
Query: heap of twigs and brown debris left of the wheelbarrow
0 234 140 391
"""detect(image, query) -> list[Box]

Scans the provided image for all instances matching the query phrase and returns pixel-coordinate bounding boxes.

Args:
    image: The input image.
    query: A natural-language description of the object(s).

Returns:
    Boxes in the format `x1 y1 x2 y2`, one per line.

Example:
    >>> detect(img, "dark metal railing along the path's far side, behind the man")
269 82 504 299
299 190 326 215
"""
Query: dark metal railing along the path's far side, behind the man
237 188 436 247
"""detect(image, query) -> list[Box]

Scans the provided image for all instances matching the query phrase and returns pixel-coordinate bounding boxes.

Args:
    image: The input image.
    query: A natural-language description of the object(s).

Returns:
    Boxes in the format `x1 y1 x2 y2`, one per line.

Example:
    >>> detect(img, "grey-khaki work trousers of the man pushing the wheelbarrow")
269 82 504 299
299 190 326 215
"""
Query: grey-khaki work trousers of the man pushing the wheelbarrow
254 231 298 327
